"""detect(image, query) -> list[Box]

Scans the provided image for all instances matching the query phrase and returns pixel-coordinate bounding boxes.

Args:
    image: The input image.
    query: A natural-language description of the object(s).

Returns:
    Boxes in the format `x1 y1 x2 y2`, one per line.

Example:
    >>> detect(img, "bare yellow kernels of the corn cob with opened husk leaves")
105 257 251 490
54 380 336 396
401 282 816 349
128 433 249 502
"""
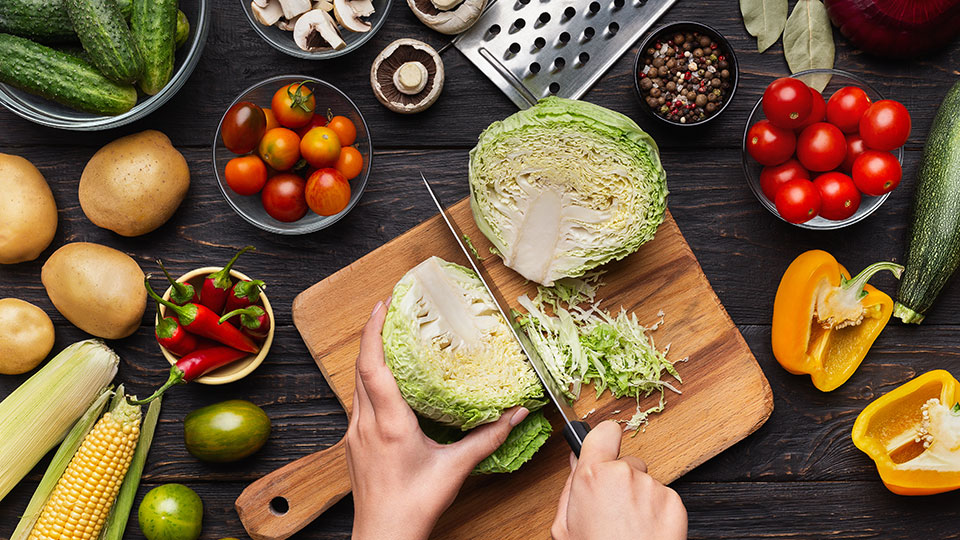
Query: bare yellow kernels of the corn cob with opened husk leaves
29 399 141 540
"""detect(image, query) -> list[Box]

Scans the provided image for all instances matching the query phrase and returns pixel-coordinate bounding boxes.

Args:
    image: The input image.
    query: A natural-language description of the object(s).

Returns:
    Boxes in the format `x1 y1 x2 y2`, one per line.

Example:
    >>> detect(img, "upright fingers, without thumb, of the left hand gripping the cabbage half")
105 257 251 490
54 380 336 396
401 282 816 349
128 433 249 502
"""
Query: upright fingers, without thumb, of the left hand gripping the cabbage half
357 302 407 415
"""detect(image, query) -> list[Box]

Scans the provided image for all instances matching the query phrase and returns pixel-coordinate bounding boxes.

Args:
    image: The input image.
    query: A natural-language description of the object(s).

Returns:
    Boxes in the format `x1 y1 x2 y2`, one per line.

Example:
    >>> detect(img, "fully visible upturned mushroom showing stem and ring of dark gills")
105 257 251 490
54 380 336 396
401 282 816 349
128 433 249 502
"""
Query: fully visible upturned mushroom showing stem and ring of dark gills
370 38 443 114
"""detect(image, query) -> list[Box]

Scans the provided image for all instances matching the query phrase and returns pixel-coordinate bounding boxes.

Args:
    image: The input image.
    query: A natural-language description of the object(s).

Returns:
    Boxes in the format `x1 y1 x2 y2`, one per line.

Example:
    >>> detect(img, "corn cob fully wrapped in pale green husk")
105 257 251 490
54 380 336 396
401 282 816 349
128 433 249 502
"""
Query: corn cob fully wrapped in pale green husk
0 340 120 501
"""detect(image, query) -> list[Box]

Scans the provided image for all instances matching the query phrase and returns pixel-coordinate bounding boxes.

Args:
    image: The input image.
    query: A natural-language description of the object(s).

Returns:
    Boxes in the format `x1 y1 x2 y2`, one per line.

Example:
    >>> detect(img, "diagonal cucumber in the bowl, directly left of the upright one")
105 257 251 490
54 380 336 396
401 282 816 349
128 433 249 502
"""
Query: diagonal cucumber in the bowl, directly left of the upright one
63 0 143 83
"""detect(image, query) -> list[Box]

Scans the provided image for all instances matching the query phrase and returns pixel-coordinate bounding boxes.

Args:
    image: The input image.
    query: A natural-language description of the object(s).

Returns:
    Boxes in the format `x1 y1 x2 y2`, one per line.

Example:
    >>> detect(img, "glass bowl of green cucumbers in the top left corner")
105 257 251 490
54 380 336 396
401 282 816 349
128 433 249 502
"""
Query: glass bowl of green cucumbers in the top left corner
0 0 210 131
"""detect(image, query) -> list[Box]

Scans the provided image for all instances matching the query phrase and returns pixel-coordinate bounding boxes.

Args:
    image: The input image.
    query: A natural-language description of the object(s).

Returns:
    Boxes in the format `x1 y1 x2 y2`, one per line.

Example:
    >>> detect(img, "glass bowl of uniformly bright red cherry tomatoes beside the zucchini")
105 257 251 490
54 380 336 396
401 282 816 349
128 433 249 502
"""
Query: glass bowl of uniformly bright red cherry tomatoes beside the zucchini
742 69 911 230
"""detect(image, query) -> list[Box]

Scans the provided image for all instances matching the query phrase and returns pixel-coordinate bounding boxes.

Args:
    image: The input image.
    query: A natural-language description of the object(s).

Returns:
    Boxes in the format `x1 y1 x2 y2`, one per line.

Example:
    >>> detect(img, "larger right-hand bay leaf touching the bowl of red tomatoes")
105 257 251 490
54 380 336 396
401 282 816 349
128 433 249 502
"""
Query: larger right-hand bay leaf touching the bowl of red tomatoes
783 0 835 92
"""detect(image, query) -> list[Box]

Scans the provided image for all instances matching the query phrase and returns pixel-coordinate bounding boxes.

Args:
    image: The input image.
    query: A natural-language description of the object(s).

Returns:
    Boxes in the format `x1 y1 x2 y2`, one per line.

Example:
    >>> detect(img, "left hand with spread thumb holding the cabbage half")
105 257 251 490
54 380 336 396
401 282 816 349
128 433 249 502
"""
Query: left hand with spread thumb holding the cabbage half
346 302 529 540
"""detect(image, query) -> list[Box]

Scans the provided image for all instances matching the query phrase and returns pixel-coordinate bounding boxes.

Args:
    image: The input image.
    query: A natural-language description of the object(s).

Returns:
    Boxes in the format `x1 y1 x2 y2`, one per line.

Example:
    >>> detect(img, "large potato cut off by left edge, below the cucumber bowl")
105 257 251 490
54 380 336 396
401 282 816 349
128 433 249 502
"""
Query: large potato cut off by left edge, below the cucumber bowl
0 154 57 264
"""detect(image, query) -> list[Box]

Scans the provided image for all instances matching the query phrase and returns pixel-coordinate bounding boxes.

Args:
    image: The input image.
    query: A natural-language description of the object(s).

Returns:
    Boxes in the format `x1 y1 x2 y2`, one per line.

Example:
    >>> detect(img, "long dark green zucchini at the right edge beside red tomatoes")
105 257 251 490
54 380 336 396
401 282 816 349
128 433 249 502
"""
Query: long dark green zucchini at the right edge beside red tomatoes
893 82 960 324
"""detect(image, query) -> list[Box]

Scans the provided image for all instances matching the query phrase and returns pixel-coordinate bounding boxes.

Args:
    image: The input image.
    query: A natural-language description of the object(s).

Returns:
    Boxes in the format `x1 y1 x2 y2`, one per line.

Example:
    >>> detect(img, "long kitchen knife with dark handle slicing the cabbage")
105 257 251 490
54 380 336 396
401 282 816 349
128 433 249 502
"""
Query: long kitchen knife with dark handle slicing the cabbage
420 172 590 457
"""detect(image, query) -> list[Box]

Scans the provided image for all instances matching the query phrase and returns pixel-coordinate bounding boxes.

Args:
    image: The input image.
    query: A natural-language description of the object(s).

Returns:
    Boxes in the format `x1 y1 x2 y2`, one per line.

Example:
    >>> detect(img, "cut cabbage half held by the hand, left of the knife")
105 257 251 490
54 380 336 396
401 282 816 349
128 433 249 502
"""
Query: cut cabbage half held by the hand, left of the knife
383 257 544 430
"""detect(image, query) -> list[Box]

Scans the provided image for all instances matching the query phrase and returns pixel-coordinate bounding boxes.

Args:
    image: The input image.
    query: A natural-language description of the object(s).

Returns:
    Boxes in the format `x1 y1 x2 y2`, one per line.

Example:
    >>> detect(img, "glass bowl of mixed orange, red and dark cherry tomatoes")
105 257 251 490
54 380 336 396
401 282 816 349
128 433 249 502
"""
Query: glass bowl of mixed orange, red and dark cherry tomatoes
213 75 373 234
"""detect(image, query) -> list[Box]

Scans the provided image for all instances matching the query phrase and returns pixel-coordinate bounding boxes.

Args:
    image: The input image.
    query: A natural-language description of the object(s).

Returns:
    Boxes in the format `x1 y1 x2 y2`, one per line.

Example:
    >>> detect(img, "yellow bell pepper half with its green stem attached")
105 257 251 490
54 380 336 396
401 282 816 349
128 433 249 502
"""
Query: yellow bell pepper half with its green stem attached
771 250 903 392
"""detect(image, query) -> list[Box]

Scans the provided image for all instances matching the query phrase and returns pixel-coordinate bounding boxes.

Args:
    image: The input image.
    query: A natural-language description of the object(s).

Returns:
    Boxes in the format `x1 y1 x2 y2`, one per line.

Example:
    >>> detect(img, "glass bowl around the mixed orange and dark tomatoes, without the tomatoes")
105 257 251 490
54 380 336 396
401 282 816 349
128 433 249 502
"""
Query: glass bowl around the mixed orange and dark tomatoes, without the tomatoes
213 75 373 235
